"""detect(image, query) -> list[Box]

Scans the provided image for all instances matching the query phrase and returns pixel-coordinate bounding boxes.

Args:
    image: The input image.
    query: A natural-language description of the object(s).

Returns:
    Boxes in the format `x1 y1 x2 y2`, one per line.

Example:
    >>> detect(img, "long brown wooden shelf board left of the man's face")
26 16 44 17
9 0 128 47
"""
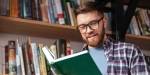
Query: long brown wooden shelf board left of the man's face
0 16 81 41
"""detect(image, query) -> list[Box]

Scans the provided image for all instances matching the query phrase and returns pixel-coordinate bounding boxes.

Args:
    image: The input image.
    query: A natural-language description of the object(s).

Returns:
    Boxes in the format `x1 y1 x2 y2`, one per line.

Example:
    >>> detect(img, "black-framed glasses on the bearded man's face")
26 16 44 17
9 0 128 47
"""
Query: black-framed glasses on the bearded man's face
77 17 104 33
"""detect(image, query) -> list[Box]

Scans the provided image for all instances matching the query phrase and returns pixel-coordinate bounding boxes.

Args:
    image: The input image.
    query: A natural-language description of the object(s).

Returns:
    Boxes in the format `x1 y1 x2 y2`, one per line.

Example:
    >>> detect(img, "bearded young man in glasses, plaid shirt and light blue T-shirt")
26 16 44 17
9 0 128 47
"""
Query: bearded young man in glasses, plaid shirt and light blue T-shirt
76 2 150 75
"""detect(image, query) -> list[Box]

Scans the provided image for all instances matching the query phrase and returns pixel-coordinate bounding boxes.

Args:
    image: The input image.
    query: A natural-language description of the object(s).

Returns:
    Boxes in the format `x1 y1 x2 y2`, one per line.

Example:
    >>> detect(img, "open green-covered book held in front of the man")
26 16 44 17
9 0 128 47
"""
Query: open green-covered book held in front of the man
42 47 102 75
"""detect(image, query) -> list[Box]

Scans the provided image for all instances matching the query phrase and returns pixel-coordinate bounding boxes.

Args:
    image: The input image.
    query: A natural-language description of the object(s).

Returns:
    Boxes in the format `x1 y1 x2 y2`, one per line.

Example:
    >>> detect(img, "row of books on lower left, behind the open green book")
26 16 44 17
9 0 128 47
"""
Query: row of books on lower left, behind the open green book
3 39 73 75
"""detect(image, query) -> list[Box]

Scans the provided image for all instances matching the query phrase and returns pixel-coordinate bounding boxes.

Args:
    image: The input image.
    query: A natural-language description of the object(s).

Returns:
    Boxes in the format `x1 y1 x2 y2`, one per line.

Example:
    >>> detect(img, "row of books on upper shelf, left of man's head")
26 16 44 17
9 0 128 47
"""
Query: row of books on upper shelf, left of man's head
0 0 94 26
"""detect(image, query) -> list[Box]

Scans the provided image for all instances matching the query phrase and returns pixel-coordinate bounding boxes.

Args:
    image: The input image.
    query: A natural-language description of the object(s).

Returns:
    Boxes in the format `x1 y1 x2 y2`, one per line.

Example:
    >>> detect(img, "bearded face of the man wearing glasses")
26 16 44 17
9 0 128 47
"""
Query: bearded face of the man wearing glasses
77 11 106 47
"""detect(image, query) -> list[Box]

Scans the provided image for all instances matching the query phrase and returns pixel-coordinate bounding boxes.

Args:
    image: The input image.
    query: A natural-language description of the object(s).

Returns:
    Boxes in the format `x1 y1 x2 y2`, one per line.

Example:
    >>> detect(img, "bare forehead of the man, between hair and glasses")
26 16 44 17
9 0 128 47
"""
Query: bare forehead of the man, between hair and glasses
77 11 102 25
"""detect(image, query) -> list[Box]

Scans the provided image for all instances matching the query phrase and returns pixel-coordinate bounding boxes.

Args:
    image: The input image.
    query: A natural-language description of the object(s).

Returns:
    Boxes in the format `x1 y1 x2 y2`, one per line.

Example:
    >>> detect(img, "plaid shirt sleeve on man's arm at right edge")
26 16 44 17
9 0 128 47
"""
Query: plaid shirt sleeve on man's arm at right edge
130 46 150 75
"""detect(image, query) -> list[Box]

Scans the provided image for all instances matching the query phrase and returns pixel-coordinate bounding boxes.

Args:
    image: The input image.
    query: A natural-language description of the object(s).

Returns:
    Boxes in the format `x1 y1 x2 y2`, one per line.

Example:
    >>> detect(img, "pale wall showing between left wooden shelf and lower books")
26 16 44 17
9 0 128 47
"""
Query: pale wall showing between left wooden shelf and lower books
0 33 83 52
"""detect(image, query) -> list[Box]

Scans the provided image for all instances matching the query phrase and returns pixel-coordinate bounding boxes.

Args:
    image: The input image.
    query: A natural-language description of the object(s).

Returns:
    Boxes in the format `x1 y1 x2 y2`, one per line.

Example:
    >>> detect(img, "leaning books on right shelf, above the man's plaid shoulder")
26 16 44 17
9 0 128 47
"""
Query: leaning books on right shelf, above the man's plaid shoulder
129 8 150 35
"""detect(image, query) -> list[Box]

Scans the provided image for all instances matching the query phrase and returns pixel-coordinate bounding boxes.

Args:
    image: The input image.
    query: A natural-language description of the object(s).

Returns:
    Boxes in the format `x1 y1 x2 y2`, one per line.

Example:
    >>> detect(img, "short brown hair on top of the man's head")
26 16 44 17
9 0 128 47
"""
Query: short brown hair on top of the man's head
76 1 103 16
